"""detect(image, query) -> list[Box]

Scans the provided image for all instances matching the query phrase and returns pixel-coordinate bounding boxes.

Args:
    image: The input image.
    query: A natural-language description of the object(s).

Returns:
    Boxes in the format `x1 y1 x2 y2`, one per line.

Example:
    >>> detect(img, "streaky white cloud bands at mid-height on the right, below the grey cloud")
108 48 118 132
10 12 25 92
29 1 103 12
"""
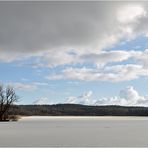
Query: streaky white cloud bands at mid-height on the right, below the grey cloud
46 49 148 82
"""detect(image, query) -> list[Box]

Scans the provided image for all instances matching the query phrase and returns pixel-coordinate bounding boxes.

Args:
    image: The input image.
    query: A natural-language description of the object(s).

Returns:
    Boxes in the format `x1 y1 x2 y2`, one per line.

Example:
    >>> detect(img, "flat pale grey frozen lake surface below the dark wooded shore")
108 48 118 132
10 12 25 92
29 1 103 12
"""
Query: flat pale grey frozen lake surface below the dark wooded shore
0 117 148 147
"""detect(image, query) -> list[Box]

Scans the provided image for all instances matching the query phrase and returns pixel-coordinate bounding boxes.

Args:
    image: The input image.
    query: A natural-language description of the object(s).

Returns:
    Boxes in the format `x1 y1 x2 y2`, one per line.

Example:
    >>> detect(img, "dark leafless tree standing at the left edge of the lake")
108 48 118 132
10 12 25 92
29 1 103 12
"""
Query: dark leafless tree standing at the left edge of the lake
0 85 19 121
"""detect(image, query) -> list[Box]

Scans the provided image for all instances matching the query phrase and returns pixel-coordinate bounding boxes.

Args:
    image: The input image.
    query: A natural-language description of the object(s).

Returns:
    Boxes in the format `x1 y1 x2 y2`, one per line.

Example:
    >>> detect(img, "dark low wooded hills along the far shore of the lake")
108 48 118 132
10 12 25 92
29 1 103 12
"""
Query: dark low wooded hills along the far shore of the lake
9 104 148 116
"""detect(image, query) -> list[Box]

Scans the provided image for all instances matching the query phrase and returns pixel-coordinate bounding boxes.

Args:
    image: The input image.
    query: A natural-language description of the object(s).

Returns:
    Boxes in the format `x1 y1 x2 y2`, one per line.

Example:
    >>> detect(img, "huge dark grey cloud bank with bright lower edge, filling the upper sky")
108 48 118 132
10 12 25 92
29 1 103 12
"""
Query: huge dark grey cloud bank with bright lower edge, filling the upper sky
0 1 147 65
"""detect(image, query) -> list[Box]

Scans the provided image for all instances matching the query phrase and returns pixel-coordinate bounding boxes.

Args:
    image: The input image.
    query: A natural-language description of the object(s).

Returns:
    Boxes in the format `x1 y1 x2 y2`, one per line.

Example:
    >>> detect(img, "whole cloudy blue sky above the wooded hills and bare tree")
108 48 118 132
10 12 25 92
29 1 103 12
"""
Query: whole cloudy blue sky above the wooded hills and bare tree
0 1 148 106
